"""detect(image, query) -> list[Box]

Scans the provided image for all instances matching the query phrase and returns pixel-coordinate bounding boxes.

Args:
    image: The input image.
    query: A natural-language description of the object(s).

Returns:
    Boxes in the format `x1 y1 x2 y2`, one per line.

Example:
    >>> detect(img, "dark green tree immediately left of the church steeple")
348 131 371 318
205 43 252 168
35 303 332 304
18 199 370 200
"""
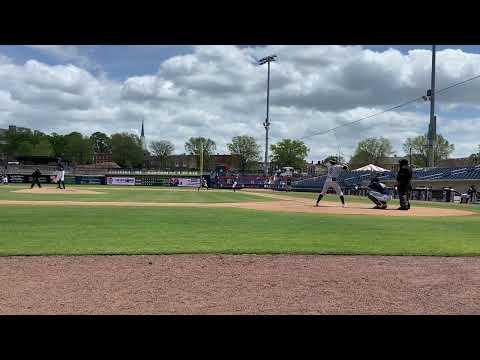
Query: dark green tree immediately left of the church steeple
111 133 144 167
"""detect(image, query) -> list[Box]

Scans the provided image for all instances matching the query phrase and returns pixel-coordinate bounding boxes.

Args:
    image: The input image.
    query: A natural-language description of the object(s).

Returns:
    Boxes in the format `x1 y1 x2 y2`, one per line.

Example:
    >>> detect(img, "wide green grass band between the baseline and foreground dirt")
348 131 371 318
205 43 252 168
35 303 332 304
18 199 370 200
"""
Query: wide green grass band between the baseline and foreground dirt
0 202 480 256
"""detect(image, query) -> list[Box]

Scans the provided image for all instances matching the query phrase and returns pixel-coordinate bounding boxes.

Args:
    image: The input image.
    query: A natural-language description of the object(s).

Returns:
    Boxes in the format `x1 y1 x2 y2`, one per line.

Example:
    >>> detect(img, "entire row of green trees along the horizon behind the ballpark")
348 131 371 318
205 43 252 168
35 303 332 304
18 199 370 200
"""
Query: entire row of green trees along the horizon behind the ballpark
0 128 480 172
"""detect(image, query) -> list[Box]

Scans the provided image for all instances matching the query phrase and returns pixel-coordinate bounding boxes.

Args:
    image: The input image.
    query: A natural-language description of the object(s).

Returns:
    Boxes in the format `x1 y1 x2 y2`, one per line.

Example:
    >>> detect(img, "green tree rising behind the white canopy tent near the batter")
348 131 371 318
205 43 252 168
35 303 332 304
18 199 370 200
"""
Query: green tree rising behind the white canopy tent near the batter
350 137 392 167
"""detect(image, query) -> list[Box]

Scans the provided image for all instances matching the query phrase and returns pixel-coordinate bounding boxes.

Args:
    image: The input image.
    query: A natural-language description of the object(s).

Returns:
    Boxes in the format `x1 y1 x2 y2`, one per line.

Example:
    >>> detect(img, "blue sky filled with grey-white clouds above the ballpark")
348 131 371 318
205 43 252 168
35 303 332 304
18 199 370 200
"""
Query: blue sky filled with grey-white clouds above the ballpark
0 45 480 161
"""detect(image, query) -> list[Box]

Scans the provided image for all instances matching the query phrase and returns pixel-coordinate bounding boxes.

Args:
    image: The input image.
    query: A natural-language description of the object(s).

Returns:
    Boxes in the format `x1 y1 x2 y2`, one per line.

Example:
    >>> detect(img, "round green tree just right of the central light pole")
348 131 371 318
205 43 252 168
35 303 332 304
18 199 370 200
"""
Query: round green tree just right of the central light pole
270 139 310 169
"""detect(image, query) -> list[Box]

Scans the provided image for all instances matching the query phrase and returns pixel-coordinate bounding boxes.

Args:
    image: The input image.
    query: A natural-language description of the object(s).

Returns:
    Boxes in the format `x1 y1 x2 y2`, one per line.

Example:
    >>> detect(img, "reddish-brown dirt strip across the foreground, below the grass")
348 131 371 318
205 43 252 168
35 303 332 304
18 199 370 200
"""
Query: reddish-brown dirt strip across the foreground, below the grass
0 255 480 314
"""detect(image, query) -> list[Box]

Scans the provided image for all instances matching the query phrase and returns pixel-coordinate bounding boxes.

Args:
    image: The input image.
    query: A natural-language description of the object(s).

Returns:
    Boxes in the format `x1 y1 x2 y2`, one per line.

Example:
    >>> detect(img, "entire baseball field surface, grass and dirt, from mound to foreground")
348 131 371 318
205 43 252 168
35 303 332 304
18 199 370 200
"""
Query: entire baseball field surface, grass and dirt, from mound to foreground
0 185 480 313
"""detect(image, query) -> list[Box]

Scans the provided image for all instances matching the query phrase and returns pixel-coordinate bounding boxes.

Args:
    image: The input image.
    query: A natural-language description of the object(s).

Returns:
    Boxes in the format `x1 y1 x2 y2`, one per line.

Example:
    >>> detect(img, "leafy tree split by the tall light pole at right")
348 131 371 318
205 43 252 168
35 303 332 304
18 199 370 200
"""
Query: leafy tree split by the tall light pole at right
403 134 455 167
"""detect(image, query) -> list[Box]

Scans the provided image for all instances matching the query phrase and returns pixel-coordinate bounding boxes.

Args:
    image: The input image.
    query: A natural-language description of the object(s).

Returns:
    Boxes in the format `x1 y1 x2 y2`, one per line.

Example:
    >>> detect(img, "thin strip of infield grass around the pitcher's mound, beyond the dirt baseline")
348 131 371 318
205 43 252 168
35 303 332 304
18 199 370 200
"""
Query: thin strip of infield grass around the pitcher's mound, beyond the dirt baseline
0 185 270 203
